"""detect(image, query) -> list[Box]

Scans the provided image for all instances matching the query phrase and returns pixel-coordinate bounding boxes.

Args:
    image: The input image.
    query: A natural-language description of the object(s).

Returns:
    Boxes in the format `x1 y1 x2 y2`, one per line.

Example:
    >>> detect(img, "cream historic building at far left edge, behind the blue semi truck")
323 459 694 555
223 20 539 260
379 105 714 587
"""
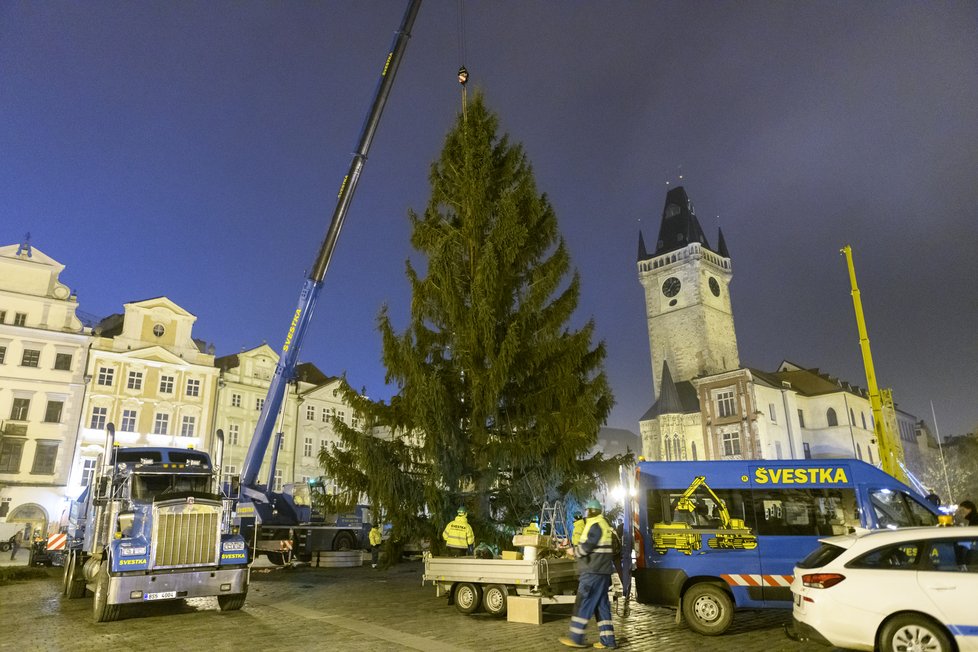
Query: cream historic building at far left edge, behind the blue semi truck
0 243 89 532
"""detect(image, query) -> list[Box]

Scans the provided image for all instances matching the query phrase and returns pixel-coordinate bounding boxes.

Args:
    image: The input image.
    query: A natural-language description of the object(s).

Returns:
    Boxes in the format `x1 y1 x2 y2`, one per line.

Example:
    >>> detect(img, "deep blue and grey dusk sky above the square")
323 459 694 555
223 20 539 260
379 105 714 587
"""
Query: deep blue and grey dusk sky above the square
0 0 978 436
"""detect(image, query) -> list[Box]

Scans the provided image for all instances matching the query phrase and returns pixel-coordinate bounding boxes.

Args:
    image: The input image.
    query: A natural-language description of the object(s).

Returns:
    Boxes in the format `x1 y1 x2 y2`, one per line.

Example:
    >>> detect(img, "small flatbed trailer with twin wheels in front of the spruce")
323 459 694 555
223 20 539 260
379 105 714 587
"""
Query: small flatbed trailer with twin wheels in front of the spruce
422 557 578 616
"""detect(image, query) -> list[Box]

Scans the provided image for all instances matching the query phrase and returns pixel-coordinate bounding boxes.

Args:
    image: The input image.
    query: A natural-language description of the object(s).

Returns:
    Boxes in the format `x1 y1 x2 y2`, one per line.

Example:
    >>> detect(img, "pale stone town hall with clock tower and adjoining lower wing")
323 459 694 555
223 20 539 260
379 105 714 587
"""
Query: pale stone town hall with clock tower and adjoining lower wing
638 187 930 482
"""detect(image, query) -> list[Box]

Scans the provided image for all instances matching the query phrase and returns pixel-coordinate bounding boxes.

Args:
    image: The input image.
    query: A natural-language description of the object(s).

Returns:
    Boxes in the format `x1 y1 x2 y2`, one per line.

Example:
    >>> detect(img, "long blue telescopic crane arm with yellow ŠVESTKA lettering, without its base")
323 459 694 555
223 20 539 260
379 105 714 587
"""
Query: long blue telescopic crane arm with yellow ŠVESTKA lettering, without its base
241 0 421 488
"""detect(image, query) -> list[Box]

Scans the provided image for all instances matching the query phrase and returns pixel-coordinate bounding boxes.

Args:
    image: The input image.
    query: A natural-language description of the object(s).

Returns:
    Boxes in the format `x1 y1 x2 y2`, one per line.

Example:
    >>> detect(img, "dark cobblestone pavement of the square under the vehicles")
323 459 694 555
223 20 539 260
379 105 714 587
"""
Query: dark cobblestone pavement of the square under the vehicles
0 562 848 652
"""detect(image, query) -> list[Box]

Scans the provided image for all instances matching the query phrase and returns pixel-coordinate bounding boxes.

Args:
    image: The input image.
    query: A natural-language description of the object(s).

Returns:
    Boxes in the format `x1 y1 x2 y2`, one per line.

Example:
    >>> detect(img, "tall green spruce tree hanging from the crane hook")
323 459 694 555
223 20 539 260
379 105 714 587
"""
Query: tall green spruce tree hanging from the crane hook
322 95 620 546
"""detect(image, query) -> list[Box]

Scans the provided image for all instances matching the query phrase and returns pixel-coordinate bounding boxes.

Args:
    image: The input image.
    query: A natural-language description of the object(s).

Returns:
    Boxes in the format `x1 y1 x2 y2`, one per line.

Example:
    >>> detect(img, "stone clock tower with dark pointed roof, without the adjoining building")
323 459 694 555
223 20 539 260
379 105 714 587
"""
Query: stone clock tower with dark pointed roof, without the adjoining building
638 186 740 396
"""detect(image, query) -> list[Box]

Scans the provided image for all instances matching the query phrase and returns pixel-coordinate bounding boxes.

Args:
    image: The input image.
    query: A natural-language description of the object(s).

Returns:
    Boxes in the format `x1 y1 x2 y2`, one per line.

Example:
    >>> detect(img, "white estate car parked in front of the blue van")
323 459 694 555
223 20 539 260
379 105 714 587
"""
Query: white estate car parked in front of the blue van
791 526 978 652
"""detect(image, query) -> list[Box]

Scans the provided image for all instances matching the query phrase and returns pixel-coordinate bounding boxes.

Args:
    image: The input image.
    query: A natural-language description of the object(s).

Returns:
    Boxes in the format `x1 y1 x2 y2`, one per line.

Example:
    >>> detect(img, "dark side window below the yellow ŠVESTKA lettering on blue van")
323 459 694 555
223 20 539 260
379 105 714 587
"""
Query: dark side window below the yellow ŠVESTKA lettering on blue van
753 488 859 536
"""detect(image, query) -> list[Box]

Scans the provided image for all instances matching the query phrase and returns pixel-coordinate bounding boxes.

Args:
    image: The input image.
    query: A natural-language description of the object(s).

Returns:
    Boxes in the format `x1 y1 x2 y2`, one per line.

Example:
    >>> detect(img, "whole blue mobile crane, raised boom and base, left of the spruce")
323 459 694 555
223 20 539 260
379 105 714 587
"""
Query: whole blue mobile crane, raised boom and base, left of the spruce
236 0 421 561
